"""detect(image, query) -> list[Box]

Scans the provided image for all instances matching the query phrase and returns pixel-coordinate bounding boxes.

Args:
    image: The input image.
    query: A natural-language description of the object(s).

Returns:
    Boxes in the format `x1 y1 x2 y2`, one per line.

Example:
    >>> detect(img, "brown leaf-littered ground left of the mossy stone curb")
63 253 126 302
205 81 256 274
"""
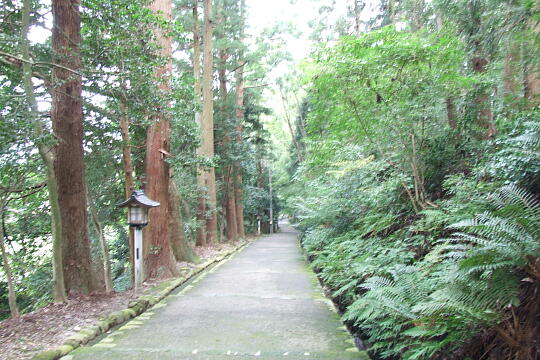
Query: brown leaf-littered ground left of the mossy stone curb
0 244 240 360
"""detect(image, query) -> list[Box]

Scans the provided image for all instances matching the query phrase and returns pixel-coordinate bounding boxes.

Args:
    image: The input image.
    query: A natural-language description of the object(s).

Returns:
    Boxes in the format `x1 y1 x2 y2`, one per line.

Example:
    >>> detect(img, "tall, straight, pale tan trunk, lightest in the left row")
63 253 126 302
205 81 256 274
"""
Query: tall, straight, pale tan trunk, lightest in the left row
201 0 217 244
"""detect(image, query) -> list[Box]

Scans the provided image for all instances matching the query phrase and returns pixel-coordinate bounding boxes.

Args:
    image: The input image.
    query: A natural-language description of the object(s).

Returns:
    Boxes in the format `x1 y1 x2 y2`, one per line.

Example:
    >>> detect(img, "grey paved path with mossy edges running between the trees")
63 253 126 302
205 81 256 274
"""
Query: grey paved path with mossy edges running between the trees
64 225 368 360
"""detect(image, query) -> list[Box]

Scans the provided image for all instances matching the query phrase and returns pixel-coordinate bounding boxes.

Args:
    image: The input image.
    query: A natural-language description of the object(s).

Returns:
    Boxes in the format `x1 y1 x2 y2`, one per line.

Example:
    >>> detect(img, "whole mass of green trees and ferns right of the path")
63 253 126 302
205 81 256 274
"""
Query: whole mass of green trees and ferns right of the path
285 1 540 359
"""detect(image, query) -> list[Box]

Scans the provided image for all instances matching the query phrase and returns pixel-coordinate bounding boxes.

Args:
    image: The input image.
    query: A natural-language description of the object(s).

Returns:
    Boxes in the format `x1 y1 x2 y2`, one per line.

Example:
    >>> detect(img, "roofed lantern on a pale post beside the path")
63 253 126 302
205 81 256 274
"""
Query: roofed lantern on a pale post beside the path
117 190 159 289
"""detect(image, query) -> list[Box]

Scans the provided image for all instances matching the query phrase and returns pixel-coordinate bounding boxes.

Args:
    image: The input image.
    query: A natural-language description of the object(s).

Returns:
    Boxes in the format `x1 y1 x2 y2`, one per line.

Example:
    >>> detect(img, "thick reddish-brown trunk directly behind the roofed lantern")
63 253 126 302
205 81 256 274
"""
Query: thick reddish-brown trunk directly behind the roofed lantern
143 0 177 278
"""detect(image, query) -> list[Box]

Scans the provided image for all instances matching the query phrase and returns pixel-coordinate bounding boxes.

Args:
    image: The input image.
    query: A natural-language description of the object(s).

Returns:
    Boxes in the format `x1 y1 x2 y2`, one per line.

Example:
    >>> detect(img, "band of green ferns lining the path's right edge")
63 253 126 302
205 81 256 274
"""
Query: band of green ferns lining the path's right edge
304 186 540 359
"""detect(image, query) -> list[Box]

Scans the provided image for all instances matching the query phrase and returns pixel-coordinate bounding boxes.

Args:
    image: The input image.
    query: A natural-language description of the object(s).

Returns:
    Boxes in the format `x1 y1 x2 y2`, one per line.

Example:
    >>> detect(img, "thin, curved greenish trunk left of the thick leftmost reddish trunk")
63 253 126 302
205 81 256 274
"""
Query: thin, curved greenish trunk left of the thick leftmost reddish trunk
21 0 67 303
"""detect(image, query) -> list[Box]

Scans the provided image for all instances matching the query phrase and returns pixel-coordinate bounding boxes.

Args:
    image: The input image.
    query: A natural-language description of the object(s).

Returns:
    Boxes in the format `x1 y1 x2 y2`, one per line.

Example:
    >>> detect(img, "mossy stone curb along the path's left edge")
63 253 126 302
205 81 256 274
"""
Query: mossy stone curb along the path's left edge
32 239 253 360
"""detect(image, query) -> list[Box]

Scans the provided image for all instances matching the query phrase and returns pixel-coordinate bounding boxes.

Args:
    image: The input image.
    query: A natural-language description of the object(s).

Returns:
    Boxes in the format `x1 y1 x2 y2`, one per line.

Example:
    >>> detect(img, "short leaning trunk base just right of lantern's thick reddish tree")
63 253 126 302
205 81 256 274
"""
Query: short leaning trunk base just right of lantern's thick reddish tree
169 178 199 263
